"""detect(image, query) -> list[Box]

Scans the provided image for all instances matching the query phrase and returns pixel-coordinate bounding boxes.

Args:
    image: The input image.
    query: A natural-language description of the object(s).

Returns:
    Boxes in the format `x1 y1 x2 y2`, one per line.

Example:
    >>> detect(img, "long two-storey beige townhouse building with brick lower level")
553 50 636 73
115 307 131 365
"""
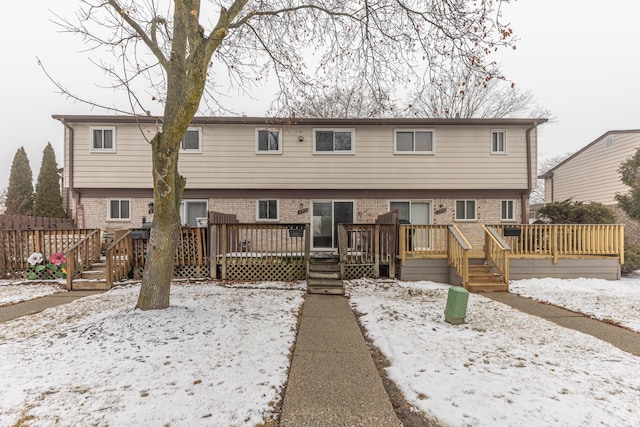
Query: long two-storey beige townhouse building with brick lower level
53 115 546 250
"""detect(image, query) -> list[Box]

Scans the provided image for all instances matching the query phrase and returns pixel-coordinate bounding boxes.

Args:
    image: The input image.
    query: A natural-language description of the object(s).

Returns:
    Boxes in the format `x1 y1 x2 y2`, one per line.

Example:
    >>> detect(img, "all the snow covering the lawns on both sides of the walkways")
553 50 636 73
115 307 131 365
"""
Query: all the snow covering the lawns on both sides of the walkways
0 277 640 427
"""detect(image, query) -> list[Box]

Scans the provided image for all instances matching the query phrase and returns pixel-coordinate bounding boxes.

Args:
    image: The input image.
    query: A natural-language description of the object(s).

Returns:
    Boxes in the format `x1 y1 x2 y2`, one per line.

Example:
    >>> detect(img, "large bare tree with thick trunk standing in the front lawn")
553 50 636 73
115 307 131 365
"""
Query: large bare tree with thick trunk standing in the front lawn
59 0 514 309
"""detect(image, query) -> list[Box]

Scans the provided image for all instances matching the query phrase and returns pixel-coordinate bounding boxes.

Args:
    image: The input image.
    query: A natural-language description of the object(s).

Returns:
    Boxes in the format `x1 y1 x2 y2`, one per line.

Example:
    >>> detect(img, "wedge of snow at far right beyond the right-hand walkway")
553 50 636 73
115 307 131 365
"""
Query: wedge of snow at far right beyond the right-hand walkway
509 276 640 332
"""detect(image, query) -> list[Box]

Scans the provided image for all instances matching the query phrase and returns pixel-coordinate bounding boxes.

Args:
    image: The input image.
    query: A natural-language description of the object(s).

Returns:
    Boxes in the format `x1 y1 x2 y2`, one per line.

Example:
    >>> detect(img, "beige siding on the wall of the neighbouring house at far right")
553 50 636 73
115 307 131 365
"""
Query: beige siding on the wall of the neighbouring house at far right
547 133 640 205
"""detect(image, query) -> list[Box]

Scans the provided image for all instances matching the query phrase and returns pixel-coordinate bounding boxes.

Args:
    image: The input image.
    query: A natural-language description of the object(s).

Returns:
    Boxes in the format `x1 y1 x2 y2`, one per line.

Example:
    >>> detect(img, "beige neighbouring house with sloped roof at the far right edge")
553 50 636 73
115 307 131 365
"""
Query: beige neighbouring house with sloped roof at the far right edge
540 130 640 243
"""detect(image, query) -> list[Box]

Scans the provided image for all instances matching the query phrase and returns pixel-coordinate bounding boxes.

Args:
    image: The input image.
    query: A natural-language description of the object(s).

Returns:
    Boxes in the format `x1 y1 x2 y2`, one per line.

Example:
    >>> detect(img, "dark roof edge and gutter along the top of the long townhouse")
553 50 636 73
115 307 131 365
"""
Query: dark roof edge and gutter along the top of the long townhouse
52 114 548 127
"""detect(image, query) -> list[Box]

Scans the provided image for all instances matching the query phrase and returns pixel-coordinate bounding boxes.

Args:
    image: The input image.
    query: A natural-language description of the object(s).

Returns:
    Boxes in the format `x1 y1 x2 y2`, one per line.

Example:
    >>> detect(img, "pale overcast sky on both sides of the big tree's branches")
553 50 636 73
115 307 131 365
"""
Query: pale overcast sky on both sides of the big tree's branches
0 0 640 188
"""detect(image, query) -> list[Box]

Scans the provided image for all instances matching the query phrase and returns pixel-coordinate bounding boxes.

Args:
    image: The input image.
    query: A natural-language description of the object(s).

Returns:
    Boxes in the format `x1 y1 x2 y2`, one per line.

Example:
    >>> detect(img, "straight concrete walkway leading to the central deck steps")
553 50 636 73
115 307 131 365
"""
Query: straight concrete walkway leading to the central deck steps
280 295 401 427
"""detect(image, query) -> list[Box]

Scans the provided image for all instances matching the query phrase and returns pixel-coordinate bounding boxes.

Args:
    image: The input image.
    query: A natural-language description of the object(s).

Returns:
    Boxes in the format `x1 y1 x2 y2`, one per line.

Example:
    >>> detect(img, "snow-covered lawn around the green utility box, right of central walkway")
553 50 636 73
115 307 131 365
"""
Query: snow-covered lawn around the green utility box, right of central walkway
348 280 640 426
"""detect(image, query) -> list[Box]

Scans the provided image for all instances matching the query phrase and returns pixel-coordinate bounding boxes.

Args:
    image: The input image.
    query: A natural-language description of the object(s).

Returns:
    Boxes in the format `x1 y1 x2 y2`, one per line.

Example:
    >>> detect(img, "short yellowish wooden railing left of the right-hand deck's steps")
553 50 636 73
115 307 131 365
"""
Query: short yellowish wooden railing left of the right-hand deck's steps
398 224 449 265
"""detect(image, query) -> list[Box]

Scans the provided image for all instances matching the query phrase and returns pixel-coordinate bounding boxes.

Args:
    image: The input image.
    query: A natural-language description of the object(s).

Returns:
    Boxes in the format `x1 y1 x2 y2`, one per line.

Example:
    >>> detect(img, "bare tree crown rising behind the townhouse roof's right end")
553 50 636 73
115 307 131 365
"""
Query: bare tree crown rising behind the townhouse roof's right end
408 64 549 118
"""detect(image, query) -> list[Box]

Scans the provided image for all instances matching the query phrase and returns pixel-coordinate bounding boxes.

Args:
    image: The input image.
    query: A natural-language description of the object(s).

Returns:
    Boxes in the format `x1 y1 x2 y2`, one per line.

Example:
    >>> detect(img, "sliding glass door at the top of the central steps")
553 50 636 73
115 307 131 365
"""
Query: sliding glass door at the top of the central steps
312 202 353 249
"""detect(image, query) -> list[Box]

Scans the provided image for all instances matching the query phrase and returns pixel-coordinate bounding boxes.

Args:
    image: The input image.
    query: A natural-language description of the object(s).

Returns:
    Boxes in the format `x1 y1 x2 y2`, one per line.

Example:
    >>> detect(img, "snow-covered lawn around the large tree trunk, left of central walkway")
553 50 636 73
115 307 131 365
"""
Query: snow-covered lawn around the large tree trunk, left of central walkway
0 284 303 426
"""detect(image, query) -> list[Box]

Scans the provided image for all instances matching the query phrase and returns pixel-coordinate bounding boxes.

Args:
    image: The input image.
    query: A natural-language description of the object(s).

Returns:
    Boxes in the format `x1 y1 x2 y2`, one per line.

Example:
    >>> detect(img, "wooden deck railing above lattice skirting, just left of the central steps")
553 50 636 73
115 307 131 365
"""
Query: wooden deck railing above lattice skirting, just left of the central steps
211 223 311 279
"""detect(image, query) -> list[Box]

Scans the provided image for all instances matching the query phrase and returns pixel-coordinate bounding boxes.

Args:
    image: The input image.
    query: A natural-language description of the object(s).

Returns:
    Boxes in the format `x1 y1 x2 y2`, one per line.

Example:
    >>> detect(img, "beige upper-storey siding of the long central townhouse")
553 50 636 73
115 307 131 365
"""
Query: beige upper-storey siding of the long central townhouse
75 124 536 189
